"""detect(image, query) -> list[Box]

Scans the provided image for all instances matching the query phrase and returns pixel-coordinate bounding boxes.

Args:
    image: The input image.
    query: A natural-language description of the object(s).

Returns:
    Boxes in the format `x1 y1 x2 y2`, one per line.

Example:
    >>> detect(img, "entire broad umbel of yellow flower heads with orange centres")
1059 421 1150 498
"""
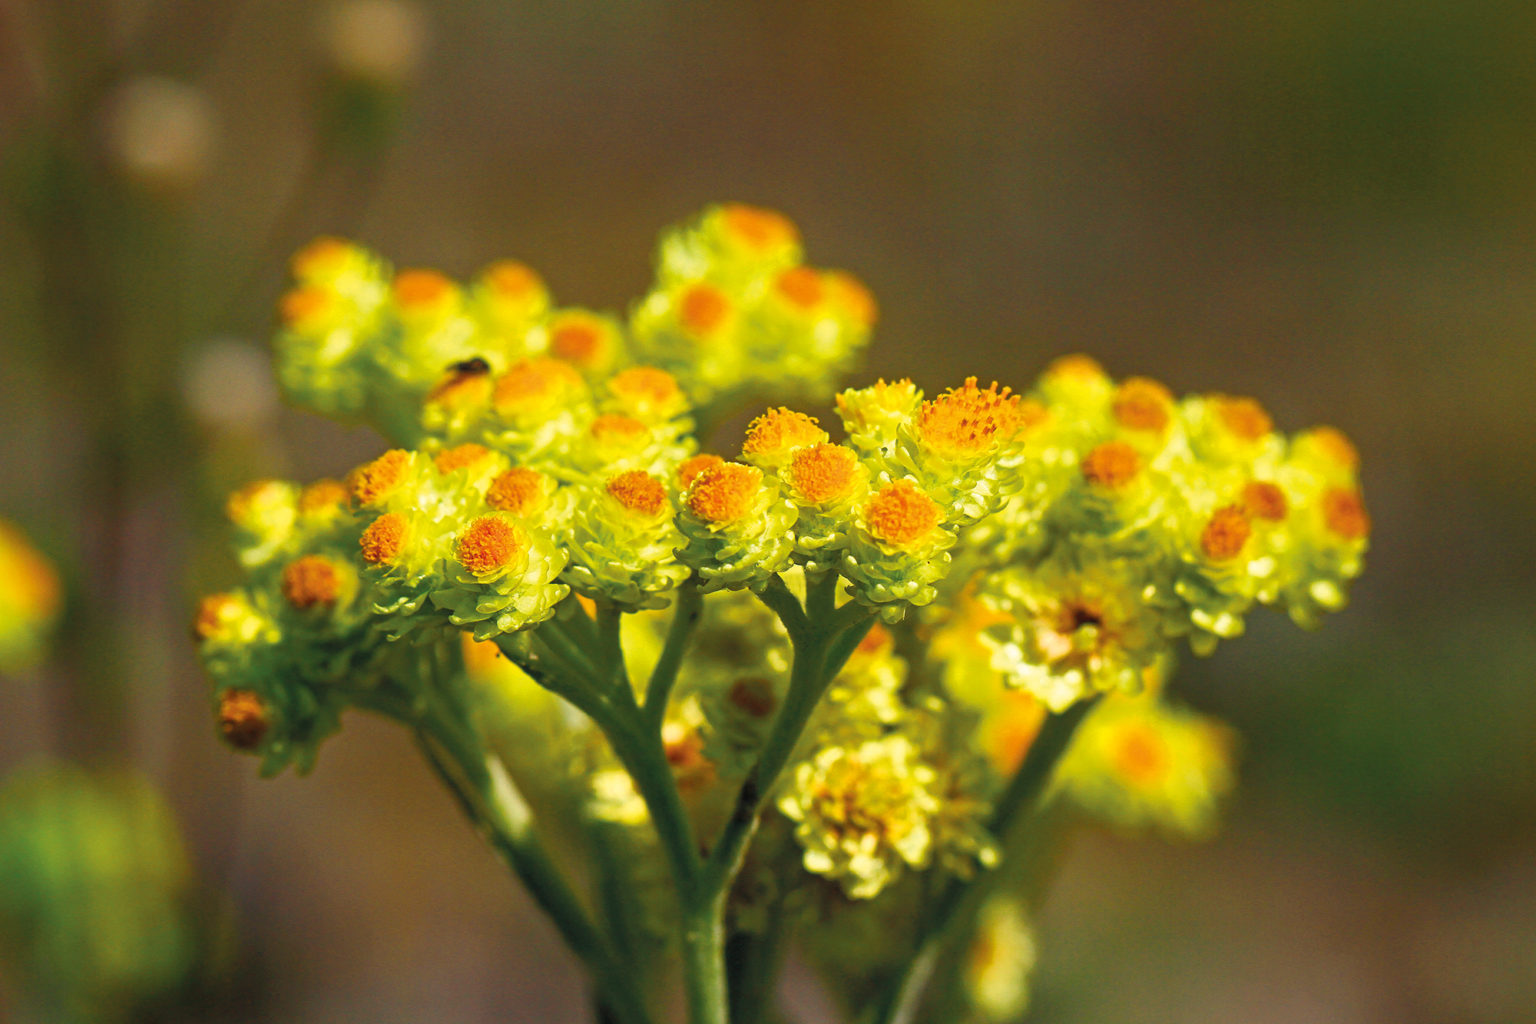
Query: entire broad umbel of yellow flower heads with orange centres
195 206 1370 1018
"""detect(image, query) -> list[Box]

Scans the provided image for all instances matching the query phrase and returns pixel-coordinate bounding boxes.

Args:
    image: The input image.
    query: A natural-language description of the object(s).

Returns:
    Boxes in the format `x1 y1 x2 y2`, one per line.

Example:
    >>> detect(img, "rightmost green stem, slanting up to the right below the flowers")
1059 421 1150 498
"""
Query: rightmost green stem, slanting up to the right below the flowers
863 697 1098 1024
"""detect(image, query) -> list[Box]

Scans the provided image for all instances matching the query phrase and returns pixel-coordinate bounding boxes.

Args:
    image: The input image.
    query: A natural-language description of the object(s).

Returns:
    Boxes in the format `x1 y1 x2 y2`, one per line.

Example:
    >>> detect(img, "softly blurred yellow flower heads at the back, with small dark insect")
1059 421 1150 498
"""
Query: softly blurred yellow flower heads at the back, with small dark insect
276 203 876 445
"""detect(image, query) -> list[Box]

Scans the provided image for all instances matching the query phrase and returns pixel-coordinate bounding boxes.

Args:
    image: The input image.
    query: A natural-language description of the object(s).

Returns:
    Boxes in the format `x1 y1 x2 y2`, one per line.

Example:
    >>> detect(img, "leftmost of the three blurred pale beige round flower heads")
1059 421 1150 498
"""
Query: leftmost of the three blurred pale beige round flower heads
104 75 215 190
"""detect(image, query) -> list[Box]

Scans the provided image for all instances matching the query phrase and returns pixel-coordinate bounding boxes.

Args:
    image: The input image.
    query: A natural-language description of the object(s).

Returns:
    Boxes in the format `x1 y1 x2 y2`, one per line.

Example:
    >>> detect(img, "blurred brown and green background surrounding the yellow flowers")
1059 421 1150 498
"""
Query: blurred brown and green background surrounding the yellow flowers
0 0 1536 1024
